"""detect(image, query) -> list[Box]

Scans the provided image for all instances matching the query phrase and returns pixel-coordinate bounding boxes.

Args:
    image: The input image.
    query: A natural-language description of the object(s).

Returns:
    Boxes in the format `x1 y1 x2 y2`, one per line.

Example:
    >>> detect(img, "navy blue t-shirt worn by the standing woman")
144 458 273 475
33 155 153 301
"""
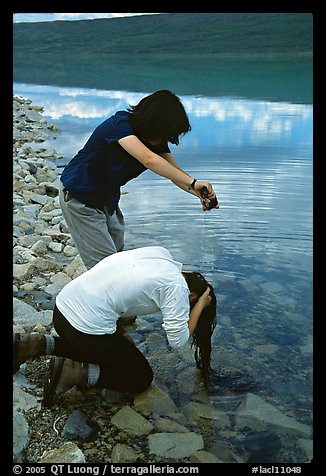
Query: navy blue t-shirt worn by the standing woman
61 111 170 214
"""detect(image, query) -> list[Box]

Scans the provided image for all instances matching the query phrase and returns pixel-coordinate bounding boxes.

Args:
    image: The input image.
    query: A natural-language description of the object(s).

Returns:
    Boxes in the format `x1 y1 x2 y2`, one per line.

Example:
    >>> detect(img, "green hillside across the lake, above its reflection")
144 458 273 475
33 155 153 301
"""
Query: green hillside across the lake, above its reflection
13 13 313 56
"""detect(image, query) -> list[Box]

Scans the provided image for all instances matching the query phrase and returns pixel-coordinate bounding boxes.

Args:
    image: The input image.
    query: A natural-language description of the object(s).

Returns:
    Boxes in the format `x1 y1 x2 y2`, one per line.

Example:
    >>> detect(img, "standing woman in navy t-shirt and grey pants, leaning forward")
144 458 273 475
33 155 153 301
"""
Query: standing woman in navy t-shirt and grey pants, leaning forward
59 90 215 269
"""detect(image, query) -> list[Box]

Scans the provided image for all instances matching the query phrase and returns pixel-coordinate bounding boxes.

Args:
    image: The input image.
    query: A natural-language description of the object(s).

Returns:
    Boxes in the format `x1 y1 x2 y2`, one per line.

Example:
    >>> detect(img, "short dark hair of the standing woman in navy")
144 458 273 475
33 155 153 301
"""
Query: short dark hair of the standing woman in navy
127 89 191 145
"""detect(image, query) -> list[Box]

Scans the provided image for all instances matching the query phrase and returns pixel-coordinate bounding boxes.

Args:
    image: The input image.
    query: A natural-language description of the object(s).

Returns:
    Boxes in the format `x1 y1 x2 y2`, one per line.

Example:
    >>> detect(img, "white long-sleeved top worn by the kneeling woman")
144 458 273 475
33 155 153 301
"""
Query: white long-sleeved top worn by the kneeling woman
56 246 190 347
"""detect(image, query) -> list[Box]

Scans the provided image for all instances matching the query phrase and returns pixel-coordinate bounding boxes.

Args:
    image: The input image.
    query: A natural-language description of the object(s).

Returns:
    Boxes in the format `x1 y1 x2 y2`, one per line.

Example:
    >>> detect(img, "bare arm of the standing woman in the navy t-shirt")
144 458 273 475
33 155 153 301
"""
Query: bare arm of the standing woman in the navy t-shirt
118 135 215 198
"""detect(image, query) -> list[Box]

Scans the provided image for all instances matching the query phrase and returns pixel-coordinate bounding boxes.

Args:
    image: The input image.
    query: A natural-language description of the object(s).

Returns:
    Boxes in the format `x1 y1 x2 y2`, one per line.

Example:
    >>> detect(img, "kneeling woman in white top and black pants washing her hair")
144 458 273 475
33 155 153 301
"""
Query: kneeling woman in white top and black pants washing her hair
13 246 216 406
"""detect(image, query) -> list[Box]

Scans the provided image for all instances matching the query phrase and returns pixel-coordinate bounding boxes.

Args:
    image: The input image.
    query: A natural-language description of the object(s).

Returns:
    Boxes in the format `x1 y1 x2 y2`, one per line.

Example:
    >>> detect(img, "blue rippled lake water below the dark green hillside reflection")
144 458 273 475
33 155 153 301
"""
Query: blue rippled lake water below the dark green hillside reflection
14 58 313 463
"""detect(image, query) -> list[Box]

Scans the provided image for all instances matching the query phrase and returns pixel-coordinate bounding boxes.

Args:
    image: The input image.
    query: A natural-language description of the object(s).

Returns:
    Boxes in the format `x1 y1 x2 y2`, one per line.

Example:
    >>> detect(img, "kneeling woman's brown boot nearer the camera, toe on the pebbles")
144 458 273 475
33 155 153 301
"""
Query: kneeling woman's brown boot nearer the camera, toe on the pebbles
43 357 87 407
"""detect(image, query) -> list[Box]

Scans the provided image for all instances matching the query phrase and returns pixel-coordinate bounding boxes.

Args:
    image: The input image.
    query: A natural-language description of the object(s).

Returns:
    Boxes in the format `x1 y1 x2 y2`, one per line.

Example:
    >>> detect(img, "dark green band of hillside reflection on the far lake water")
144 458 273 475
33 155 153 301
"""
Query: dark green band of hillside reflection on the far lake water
13 55 312 104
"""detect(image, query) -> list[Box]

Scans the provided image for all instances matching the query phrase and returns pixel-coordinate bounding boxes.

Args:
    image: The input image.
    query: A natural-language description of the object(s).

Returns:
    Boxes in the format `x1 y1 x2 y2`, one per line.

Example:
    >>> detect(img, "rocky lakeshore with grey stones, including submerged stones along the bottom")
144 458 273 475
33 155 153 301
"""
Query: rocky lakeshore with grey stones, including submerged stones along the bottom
13 97 312 464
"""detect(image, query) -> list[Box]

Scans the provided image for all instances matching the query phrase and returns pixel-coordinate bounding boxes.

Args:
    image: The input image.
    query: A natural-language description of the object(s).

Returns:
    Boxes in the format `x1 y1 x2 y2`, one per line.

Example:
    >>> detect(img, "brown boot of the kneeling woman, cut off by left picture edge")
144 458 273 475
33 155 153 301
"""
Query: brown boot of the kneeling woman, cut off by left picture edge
13 333 45 374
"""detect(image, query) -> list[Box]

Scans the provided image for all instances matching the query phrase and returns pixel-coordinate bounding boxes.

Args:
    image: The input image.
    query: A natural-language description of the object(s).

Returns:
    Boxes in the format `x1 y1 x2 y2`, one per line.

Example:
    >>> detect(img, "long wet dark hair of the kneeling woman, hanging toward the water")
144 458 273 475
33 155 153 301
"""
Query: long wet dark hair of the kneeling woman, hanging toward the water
182 272 217 389
